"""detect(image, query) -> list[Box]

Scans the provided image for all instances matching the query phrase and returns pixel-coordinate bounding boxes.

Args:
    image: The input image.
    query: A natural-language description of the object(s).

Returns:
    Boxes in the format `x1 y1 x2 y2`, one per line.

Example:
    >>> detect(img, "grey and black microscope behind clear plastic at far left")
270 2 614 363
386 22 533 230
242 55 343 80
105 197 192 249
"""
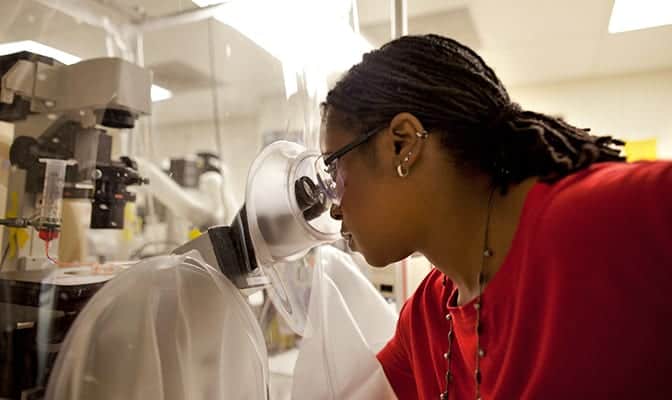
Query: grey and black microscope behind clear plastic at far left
0 52 151 271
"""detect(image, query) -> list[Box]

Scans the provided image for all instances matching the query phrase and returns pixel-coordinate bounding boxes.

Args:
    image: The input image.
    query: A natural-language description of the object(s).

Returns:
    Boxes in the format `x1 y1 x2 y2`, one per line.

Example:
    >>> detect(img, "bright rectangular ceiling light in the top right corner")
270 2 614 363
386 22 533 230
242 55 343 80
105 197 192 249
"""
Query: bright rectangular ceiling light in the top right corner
609 0 672 33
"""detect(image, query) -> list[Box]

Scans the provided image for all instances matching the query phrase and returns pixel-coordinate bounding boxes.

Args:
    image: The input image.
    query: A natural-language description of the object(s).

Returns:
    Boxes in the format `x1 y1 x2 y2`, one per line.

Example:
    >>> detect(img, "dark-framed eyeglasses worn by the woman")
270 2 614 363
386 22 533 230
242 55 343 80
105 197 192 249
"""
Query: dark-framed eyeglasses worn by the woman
315 127 384 205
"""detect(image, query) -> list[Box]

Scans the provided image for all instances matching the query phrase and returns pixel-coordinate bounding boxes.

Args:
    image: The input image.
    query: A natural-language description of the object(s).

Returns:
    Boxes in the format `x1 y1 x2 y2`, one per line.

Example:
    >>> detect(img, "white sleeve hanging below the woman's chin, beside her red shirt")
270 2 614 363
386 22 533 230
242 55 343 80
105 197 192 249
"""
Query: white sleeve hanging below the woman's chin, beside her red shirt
292 246 397 400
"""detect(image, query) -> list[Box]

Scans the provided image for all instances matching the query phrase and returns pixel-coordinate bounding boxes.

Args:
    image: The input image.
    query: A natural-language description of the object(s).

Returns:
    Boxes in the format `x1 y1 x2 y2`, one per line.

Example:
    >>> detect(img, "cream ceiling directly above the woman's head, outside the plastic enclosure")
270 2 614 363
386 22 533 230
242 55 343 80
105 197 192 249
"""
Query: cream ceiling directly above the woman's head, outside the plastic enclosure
359 0 672 86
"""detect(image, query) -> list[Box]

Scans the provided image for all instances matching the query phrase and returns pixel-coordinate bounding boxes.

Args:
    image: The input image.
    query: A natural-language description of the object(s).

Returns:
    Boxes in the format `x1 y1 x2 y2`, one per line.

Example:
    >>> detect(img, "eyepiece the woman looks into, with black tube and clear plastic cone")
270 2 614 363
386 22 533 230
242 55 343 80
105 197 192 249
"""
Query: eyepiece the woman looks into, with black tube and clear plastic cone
174 141 340 333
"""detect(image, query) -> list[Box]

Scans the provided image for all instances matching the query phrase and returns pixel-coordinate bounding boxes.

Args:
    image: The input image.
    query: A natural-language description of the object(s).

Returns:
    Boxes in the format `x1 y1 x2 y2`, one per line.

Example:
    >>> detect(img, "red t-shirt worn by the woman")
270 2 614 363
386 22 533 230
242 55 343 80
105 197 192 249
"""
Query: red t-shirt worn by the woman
378 162 672 400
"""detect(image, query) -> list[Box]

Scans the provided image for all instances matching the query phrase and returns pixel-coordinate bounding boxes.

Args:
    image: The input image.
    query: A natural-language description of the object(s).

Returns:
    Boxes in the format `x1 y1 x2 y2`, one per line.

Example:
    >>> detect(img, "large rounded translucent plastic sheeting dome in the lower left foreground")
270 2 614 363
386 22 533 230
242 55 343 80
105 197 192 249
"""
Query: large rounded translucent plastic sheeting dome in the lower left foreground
46 253 268 400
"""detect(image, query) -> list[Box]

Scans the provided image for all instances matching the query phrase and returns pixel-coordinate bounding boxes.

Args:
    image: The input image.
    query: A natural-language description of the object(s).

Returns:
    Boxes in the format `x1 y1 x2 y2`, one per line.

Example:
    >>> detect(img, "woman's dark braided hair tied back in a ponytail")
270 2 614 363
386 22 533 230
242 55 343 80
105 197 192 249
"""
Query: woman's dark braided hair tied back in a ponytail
323 35 623 192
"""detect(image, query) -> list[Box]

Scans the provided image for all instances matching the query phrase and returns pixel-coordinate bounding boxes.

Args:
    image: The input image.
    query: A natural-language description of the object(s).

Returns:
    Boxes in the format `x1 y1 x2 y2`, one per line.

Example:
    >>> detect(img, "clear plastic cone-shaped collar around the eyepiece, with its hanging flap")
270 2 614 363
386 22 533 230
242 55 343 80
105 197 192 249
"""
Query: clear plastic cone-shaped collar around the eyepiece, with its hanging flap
245 141 341 334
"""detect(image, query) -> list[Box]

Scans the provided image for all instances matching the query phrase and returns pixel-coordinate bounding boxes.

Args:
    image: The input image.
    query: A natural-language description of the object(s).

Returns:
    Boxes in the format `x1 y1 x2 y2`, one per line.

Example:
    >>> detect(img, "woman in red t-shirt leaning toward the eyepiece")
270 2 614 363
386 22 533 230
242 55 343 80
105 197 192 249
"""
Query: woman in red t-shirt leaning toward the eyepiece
322 35 672 399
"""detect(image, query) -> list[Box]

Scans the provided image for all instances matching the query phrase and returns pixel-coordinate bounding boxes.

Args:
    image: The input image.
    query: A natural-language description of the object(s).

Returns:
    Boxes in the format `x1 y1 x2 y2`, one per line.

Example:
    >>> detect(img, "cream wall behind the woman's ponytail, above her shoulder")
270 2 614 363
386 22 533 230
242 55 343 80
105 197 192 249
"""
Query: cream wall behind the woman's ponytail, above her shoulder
509 69 672 159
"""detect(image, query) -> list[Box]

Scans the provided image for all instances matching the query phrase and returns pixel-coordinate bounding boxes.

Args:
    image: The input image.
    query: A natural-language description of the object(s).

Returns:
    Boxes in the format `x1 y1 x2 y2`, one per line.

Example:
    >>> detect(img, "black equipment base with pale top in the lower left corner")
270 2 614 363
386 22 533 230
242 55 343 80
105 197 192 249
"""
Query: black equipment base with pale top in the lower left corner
0 268 113 400
